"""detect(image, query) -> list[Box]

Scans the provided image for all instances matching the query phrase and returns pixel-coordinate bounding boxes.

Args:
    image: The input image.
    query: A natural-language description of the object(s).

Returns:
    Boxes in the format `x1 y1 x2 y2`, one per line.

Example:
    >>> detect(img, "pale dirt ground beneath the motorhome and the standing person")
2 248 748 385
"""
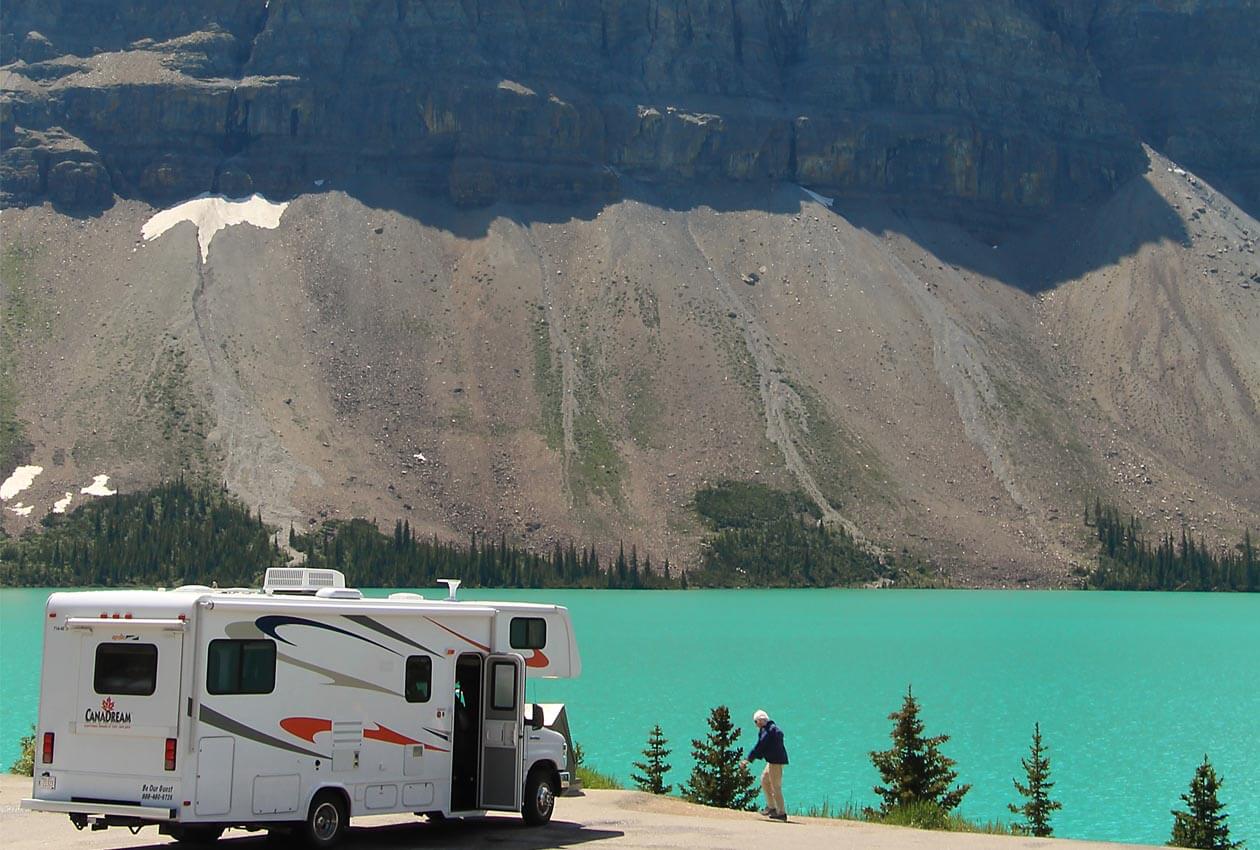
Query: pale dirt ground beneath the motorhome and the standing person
0 776 1159 850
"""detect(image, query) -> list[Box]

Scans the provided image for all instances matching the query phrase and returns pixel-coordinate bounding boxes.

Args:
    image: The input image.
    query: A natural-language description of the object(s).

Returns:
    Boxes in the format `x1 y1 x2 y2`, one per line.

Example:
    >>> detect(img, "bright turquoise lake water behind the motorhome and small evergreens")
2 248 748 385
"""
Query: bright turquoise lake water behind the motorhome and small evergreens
0 589 1260 847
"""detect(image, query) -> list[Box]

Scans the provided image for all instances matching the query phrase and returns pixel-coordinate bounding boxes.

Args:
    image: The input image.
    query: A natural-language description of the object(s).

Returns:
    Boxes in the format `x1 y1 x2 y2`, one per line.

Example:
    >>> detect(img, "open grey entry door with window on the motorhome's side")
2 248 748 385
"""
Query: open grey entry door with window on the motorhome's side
478 655 525 811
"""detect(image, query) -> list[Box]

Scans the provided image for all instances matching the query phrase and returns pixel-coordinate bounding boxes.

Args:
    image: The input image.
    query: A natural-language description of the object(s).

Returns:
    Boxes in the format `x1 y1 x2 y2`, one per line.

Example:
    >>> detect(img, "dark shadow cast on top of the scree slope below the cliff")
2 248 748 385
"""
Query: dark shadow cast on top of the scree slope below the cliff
339 167 1189 292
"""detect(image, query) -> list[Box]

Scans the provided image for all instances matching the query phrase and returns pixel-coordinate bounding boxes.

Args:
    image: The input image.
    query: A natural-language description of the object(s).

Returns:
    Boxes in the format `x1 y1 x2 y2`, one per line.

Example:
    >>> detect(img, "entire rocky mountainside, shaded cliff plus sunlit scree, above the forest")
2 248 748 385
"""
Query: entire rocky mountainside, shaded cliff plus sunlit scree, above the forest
0 0 1260 584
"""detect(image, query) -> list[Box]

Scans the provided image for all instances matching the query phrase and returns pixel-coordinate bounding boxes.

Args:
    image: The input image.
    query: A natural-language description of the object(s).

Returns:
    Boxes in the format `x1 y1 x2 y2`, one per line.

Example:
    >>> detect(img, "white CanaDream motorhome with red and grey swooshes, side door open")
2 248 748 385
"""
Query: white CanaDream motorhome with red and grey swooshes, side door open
21 568 581 846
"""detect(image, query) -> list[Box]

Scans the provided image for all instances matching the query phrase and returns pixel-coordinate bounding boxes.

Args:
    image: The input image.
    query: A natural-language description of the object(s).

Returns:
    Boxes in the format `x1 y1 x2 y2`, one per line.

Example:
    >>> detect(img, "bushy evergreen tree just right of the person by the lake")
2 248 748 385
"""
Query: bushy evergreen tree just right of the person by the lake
871 688 971 815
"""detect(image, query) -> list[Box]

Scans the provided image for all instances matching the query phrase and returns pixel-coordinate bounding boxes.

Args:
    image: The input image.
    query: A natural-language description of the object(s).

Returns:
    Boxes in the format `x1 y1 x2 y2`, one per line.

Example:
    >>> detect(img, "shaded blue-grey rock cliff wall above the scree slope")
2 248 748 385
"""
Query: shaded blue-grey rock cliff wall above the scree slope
0 0 1260 222
